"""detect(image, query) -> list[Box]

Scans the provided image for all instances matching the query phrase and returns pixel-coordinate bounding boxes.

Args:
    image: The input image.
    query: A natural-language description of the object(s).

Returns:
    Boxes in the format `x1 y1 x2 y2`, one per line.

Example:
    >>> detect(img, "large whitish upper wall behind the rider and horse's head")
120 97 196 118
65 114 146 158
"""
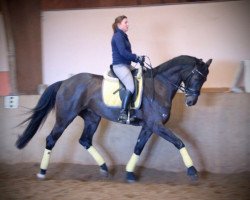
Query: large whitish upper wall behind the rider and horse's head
42 0 250 87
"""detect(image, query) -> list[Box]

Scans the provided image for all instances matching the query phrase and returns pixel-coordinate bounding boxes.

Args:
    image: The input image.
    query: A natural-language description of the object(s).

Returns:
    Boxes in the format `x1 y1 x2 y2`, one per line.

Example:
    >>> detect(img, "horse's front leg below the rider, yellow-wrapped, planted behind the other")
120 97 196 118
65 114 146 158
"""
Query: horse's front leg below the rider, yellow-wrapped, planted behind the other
126 125 153 183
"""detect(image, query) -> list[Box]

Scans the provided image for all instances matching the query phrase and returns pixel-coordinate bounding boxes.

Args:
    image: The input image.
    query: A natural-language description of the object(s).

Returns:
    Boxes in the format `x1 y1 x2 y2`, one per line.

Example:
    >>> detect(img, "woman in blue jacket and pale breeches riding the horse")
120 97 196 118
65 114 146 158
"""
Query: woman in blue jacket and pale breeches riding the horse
111 15 145 123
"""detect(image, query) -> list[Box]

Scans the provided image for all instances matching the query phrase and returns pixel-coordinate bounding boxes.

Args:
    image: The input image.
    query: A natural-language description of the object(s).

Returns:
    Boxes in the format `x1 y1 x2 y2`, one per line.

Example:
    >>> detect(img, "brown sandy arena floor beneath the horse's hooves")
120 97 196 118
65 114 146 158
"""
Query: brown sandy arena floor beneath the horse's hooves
0 163 250 200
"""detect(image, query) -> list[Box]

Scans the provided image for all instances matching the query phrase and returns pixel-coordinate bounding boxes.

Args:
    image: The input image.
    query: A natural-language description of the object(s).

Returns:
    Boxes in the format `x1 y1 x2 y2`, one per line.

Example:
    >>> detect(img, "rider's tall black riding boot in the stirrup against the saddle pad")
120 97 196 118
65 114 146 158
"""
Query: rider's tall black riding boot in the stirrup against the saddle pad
118 90 133 124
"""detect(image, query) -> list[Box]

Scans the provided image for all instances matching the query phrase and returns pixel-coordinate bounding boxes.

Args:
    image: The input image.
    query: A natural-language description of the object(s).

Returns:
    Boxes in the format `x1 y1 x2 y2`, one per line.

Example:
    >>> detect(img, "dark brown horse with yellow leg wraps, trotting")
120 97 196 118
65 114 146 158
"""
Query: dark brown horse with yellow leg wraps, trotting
16 55 212 183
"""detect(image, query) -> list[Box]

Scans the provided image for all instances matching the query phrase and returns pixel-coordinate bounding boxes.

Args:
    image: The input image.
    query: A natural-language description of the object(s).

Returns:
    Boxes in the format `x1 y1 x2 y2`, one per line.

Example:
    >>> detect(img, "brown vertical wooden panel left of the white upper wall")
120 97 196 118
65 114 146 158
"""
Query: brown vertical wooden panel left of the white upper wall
3 0 42 94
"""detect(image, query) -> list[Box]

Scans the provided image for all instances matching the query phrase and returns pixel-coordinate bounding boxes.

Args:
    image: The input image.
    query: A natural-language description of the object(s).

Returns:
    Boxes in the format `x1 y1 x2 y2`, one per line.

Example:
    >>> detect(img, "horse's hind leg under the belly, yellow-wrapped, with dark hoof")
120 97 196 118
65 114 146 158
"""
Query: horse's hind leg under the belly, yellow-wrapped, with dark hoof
79 110 108 176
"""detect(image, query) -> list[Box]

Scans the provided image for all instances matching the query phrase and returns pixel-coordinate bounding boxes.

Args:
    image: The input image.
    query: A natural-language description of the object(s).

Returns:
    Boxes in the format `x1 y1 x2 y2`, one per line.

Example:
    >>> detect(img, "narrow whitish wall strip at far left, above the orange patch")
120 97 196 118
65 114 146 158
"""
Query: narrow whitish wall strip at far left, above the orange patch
0 13 9 72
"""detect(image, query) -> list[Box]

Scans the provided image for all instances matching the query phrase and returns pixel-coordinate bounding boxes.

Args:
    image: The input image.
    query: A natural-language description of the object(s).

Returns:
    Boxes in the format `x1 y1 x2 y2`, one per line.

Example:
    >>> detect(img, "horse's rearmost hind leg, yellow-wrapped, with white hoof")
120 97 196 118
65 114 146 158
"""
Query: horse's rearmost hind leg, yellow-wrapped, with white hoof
37 113 77 179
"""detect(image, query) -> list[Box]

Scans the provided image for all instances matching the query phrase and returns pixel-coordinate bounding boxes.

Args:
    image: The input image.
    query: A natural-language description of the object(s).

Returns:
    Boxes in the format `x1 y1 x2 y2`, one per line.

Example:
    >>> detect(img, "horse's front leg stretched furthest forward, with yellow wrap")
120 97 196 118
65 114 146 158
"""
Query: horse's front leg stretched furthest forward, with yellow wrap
153 123 198 180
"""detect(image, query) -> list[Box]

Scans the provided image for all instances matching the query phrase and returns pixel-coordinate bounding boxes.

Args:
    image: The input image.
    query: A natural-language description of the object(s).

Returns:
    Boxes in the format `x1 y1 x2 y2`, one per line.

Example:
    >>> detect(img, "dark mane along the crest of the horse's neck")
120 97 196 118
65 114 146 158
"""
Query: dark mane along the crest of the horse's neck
153 55 198 75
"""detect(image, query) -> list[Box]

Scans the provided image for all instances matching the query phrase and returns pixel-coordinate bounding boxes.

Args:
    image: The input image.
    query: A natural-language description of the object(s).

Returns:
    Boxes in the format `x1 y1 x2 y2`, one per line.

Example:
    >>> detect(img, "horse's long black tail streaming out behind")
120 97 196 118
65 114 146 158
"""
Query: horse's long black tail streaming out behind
16 81 62 149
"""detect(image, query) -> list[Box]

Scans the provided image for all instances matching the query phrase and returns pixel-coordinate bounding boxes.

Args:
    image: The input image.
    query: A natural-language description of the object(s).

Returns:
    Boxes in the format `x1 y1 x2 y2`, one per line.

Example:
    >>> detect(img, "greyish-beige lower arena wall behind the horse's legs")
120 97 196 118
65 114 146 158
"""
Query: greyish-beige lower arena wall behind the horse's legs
0 93 250 173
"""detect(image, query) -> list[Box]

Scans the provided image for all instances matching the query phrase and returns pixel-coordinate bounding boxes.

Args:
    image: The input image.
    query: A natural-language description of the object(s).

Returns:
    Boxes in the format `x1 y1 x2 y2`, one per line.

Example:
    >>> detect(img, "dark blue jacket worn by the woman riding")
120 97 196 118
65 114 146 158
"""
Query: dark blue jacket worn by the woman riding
111 28 137 65
